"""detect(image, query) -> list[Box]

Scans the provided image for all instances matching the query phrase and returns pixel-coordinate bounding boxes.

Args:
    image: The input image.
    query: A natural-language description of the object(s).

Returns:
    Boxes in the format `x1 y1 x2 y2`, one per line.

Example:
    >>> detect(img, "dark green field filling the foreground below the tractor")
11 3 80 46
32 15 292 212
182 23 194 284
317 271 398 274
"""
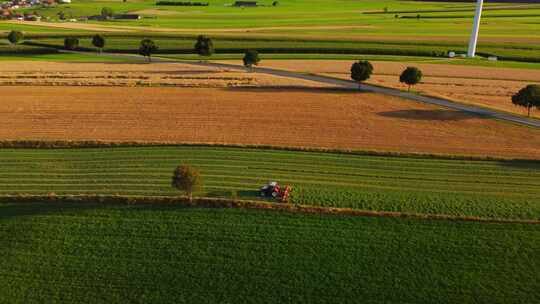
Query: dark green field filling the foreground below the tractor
0 202 540 303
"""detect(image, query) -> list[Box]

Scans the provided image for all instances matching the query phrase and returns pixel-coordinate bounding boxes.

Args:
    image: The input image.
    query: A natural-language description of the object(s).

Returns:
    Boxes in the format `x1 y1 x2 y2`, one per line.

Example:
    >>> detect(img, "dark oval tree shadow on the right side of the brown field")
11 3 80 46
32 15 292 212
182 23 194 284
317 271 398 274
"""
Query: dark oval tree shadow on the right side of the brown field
377 110 484 121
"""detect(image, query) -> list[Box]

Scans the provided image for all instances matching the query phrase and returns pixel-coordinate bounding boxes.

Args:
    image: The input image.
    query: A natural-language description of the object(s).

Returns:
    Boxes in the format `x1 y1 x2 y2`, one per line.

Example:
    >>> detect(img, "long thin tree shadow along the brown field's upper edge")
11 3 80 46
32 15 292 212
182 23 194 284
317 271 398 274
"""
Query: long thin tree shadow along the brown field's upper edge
223 85 362 94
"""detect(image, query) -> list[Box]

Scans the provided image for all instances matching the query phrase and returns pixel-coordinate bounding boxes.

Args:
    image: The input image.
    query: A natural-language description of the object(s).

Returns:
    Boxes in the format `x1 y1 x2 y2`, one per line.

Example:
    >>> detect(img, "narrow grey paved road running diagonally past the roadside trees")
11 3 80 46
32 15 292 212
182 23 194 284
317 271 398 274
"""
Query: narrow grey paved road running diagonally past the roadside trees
63 51 540 128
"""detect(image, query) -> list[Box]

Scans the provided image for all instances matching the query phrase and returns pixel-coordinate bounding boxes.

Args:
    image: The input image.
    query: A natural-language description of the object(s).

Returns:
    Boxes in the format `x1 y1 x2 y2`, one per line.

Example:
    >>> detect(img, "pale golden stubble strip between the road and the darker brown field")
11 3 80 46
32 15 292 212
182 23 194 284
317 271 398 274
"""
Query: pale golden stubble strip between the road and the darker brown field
0 61 330 88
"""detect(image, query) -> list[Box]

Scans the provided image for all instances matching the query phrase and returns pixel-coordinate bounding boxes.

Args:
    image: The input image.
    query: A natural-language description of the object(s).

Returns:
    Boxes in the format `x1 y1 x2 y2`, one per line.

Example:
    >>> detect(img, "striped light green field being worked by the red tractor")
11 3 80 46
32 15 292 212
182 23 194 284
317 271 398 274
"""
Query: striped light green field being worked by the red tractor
4 147 540 220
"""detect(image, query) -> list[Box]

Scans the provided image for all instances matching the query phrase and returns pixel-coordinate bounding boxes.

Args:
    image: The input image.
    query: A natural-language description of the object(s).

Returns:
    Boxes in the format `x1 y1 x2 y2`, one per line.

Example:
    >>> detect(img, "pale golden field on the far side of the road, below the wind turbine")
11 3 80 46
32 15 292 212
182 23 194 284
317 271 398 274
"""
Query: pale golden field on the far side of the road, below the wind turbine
261 60 540 118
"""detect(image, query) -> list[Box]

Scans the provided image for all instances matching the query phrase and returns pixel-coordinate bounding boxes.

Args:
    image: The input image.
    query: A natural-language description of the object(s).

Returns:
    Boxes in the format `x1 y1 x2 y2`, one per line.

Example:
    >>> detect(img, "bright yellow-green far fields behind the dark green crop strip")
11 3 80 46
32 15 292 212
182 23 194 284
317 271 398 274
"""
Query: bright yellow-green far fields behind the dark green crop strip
14 0 540 38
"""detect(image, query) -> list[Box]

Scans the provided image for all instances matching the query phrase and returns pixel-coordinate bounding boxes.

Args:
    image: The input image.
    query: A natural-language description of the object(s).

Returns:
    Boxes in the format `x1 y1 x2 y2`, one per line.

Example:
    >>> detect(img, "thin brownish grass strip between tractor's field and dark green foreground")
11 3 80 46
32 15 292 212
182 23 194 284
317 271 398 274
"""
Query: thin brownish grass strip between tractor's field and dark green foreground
0 194 540 225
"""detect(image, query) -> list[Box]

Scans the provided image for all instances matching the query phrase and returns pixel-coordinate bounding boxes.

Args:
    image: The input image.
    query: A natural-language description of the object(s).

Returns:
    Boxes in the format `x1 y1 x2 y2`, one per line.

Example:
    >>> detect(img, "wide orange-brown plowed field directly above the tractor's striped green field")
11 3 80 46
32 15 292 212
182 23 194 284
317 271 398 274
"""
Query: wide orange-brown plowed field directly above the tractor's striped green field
4 87 540 159
